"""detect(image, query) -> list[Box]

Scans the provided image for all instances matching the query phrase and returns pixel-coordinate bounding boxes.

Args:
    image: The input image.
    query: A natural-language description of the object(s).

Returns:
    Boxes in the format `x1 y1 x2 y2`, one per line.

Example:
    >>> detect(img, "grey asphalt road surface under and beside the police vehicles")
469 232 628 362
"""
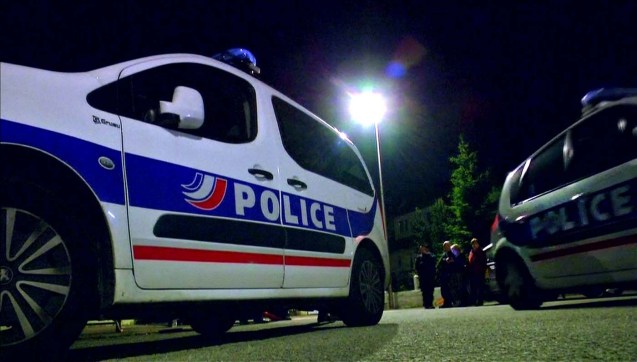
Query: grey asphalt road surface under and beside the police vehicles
68 295 637 361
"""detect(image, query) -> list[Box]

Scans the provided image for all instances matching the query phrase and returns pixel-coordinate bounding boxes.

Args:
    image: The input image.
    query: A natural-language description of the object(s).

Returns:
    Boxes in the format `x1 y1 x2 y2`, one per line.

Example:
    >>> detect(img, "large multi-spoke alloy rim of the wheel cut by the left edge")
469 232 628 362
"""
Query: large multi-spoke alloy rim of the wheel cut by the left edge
0 207 71 346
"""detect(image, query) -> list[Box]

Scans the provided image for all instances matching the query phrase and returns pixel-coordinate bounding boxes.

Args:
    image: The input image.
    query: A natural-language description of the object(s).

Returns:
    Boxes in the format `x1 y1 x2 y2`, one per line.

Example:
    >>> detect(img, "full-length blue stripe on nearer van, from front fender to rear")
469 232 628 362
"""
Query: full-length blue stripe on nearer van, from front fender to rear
0 119 377 237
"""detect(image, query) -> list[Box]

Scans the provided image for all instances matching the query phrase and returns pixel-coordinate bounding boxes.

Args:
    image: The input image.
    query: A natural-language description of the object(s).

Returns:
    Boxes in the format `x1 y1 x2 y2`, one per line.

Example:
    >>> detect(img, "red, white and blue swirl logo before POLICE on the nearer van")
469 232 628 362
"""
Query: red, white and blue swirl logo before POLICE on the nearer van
181 172 228 211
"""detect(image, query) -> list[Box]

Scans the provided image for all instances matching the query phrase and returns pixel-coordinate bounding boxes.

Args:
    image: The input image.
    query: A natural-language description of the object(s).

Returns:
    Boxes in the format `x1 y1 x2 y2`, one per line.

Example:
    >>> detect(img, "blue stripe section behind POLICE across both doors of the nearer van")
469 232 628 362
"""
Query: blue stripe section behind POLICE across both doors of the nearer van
126 154 376 237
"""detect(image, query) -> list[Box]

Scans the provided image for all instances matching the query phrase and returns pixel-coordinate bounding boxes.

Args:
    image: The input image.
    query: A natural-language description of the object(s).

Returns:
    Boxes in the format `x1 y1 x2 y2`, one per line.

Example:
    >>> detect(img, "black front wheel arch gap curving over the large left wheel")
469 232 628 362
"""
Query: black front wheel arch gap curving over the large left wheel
0 144 115 313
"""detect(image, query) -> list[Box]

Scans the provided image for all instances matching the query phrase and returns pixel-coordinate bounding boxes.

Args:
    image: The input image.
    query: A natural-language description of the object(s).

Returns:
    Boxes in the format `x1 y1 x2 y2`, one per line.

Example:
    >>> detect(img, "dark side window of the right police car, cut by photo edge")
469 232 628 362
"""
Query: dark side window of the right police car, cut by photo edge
568 105 637 180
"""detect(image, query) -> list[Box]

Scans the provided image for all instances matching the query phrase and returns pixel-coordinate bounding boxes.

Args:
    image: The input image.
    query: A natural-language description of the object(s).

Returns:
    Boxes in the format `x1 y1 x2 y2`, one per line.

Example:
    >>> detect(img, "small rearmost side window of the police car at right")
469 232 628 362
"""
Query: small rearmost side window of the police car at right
517 135 565 201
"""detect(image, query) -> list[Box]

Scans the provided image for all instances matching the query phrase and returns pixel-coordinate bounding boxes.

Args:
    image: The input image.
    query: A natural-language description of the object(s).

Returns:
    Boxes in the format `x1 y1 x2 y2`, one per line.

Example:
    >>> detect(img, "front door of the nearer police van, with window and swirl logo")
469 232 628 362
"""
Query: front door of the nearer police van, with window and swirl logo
119 59 285 289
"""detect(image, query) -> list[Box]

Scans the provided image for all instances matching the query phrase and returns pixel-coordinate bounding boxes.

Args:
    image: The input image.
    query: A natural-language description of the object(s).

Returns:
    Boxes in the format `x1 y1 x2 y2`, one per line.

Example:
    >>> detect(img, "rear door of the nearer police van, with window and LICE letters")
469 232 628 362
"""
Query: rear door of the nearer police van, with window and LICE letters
272 97 373 288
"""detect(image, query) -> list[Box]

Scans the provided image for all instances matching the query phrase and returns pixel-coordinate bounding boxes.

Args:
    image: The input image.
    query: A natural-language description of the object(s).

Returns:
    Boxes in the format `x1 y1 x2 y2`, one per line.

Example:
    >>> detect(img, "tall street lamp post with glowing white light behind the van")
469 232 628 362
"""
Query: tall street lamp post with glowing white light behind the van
349 91 396 308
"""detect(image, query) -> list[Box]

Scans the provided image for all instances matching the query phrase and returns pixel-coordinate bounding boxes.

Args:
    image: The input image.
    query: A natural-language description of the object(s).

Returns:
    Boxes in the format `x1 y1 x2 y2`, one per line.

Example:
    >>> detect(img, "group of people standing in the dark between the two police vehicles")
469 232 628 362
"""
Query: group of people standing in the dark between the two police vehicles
415 238 487 309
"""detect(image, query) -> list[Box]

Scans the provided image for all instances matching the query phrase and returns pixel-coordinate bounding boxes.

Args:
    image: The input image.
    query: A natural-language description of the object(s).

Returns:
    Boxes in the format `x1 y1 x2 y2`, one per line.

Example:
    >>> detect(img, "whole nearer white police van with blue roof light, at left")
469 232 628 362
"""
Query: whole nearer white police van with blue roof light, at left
0 49 389 357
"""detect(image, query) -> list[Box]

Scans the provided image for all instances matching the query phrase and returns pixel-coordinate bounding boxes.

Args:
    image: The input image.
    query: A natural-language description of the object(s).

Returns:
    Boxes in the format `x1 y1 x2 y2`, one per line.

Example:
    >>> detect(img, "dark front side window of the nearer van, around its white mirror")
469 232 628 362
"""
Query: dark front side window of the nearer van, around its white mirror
87 63 257 143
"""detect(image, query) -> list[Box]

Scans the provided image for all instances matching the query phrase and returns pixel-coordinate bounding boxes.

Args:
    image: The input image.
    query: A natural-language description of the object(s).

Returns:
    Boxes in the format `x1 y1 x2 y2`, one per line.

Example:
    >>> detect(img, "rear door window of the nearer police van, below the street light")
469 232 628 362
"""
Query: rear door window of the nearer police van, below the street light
272 97 374 196
